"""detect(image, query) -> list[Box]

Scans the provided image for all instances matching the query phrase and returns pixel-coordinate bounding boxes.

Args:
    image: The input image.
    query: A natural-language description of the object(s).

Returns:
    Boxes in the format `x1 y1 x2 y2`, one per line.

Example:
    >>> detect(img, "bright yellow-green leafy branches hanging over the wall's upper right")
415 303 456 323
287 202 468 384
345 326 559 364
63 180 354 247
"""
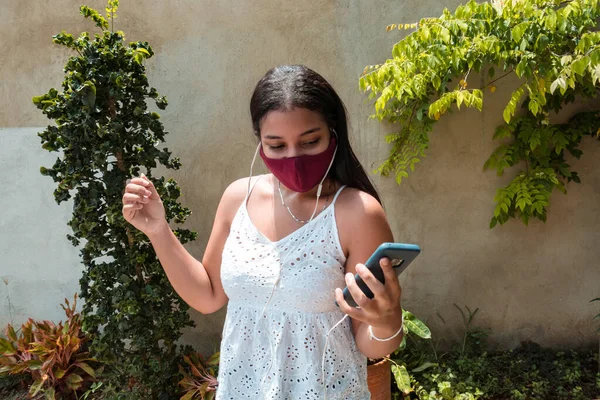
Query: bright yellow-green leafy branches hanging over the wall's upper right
360 0 600 227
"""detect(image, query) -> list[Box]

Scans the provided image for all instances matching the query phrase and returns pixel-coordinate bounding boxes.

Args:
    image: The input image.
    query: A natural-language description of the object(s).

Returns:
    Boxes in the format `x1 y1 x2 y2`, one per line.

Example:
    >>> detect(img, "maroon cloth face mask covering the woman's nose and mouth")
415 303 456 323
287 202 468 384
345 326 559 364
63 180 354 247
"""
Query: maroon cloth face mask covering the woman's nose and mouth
260 136 337 193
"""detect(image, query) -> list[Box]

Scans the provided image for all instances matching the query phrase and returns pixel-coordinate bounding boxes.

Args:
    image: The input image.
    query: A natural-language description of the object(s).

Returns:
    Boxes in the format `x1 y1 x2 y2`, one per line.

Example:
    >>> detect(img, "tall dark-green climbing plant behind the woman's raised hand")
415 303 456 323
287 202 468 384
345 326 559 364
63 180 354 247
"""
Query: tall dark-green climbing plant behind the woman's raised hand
33 0 196 399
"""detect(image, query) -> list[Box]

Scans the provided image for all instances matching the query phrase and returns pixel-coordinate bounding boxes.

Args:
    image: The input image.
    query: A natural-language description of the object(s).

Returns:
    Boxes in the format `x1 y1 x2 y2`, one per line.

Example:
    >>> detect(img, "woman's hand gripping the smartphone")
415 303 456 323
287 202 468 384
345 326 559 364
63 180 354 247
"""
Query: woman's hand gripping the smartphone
335 258 402 332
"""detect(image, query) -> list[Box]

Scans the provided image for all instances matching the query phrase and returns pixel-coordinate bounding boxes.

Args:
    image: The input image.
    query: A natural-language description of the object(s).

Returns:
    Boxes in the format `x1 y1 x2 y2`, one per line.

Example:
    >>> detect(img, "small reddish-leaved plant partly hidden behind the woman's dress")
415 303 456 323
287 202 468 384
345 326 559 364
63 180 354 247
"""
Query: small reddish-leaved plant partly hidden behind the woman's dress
179 352 219 400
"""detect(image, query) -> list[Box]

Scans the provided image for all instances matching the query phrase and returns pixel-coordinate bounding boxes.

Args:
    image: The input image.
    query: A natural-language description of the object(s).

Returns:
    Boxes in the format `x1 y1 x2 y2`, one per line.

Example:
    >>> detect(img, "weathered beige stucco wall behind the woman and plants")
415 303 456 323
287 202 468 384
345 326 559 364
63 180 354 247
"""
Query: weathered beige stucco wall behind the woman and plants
0 0 600 351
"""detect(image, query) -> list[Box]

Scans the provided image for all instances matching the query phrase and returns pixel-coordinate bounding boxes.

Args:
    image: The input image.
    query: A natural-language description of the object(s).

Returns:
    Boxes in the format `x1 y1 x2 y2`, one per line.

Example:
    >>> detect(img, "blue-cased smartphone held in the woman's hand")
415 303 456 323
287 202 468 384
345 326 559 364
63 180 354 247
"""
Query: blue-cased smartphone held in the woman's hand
335 243 421 307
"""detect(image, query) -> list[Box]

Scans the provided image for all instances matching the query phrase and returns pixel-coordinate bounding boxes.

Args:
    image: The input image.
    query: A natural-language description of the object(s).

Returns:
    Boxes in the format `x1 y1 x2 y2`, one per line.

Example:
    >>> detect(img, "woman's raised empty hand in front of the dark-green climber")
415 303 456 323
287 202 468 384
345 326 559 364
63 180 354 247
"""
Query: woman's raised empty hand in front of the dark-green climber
123 174 167 236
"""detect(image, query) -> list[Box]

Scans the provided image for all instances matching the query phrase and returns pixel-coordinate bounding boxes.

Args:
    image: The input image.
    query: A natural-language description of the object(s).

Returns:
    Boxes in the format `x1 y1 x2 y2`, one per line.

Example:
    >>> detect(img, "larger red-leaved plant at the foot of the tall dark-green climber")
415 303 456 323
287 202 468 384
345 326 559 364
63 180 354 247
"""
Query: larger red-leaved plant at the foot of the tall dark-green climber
0 295 101 399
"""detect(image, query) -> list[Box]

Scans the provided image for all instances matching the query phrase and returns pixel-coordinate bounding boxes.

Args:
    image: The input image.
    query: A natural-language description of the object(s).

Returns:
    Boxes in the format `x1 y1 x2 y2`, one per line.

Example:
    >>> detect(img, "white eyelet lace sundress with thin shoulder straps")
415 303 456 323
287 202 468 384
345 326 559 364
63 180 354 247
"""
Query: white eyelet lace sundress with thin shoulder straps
217 183 370 400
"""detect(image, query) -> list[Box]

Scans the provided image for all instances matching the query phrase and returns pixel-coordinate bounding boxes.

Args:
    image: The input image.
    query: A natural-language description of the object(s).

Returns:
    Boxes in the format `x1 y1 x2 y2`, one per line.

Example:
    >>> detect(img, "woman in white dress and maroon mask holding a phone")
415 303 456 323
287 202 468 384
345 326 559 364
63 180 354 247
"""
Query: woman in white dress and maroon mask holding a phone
123 66 402 400
